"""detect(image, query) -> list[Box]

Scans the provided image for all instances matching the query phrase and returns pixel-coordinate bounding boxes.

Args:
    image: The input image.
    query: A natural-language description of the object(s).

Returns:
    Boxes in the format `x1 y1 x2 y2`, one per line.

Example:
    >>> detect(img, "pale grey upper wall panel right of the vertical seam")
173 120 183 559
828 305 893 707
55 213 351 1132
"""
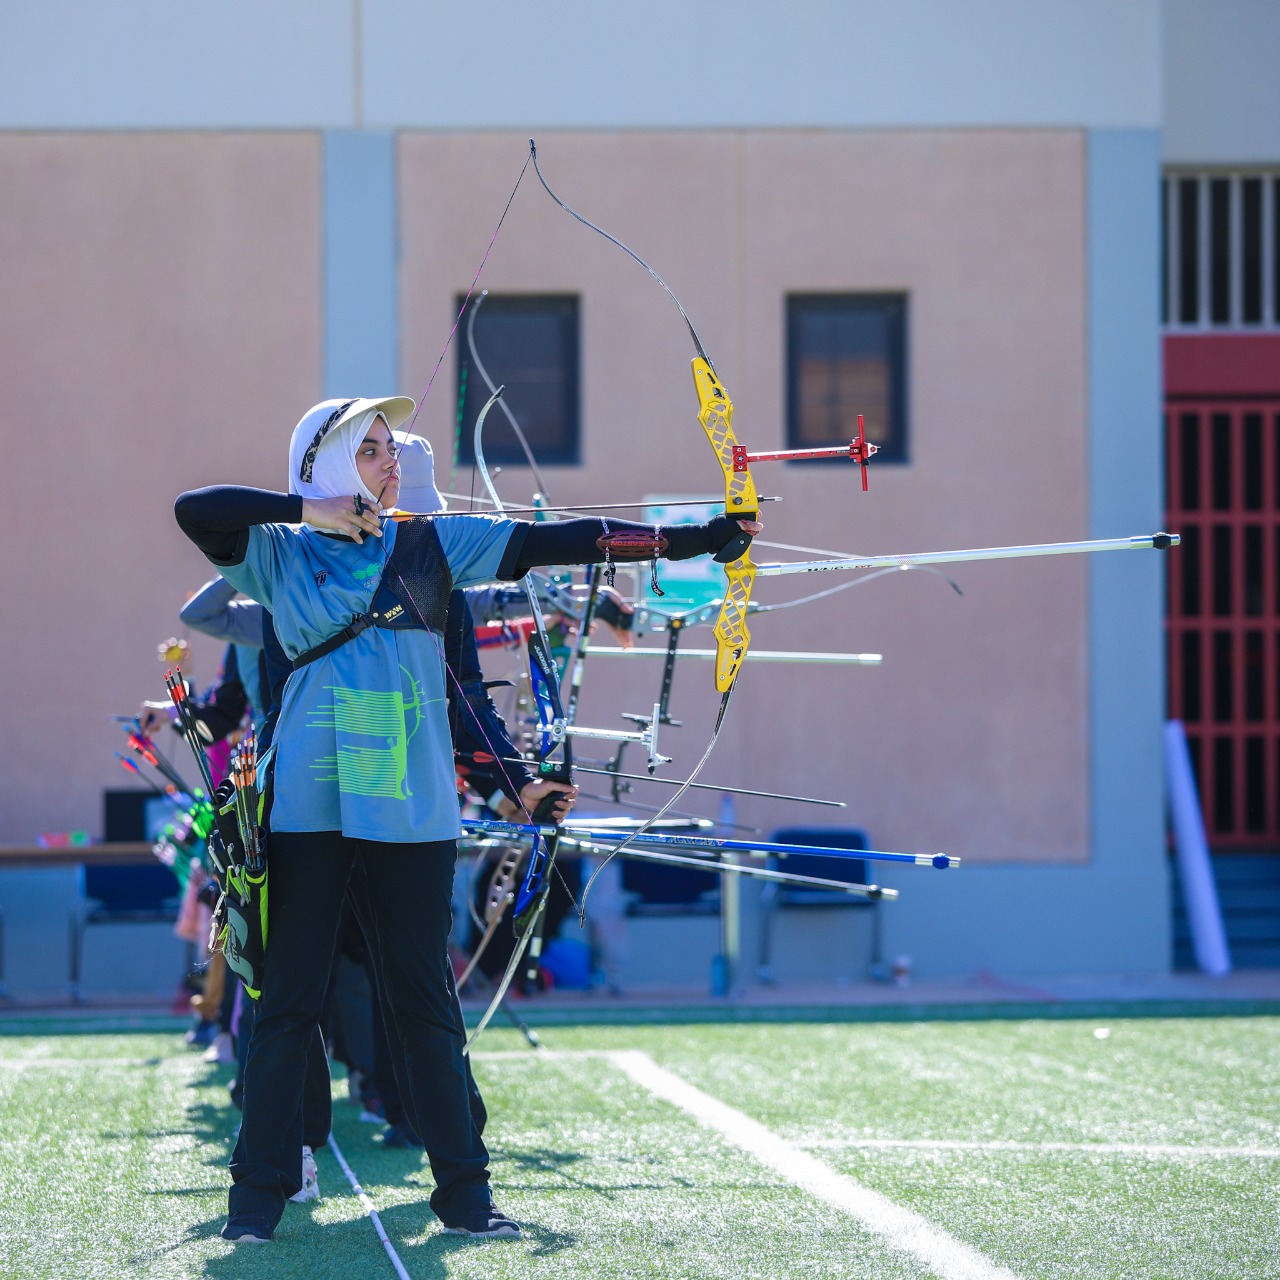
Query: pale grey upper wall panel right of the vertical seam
365 0 1160 128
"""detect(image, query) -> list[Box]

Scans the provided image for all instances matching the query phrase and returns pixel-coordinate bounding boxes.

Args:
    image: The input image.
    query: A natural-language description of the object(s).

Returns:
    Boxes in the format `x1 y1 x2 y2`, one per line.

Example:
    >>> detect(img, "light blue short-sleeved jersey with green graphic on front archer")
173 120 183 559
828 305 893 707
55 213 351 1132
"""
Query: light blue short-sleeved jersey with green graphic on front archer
219 515 518 844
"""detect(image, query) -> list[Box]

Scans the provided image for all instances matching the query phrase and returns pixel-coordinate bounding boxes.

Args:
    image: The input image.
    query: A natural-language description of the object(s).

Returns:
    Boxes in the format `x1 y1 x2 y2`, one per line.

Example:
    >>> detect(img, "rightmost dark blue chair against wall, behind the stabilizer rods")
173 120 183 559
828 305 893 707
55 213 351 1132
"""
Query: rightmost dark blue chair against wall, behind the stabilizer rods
756 827 884 983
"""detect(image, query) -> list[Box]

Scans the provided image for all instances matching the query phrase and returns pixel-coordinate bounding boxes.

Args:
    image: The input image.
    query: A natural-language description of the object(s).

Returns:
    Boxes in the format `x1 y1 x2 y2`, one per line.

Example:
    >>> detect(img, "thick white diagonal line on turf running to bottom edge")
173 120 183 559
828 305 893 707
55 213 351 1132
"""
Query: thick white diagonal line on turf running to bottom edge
607 1050 1018 1280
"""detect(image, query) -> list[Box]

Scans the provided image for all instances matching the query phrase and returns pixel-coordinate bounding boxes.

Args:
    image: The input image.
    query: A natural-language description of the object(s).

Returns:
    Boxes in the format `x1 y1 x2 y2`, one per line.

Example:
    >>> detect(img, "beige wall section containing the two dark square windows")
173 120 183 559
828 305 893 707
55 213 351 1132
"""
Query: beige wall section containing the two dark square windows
401 131 1090 861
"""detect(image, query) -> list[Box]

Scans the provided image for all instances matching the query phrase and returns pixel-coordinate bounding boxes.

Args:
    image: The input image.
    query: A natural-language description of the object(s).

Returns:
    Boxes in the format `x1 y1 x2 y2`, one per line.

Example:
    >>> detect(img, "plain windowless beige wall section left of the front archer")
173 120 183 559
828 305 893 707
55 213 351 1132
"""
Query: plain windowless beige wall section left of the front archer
0 133 321 844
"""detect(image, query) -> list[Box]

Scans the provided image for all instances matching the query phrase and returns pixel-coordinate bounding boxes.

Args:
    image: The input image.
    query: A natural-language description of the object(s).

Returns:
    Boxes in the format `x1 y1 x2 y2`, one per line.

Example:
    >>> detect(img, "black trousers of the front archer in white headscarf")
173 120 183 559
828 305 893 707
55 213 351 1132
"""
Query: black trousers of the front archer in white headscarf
229 832 489 1229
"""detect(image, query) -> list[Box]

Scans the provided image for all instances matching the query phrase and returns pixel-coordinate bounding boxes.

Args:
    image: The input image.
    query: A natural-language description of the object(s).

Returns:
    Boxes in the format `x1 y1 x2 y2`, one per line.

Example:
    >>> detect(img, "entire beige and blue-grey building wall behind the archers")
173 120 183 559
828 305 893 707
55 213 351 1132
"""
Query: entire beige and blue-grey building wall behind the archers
0 0 1172 993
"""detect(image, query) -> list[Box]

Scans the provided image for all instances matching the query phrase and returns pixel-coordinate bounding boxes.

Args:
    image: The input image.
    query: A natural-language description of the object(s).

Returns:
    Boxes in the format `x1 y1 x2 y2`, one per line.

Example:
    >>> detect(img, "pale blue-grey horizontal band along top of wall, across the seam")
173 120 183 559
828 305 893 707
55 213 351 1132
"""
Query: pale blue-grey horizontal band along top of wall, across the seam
0 0 1161 129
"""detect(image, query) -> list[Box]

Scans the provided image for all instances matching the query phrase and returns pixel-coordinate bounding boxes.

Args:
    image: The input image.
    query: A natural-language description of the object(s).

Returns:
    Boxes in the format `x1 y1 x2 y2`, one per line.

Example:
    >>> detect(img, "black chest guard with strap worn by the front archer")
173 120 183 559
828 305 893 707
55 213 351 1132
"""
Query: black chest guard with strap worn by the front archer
293 517 453 671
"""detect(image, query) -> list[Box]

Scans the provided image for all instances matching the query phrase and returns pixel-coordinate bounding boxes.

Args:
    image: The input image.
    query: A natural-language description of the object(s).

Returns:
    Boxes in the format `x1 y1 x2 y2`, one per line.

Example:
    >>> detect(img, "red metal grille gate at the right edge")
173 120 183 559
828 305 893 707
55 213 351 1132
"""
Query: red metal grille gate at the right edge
1165 394 1280 850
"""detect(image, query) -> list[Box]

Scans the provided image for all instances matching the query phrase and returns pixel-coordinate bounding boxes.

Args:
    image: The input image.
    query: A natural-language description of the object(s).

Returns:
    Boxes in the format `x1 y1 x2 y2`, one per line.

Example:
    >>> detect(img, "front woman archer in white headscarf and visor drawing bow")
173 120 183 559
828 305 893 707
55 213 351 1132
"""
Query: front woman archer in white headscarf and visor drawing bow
175 397 760 1243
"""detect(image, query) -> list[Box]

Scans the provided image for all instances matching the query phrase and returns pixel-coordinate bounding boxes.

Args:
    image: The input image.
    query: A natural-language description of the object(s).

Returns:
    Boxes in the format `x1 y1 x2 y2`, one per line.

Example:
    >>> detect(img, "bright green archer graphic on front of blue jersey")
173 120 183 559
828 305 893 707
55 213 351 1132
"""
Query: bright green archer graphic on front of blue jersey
308 667 424 800
